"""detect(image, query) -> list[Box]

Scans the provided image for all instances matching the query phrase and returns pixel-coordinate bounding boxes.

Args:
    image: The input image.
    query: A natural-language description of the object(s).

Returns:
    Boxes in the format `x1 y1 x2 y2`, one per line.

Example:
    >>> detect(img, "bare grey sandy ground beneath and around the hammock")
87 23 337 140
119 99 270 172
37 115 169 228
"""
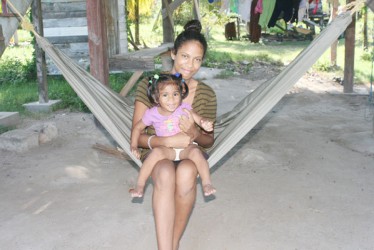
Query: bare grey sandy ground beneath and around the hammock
0 71 374 250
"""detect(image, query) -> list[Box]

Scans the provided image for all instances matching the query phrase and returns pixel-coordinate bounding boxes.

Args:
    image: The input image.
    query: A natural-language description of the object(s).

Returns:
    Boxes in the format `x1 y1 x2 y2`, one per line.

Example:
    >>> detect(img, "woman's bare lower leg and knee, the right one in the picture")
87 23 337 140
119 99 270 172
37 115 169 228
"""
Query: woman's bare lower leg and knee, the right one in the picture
173 160 197 250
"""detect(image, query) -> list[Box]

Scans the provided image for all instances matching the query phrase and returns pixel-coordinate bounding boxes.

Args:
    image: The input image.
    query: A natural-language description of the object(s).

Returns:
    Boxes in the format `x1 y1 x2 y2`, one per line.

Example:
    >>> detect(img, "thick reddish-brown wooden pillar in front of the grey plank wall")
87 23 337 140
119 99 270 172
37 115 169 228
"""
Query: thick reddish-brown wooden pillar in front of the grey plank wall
86 0 109 85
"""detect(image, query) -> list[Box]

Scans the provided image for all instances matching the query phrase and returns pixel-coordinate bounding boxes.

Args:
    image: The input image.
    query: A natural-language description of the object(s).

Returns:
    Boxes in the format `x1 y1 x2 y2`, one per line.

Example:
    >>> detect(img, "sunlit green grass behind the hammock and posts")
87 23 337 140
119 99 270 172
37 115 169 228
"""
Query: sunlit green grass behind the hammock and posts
0 18 373 115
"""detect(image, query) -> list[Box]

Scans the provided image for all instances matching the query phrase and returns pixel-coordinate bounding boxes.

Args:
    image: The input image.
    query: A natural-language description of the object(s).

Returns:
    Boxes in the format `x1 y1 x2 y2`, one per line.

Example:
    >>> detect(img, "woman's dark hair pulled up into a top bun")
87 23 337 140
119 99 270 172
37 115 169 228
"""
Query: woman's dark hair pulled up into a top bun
173 20 208 57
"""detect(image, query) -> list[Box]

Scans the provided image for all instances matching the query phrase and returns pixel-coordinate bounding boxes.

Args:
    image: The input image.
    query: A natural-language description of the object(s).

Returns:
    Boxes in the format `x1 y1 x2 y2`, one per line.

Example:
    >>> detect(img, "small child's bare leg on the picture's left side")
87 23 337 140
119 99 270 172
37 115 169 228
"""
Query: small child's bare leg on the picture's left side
129 147 175 197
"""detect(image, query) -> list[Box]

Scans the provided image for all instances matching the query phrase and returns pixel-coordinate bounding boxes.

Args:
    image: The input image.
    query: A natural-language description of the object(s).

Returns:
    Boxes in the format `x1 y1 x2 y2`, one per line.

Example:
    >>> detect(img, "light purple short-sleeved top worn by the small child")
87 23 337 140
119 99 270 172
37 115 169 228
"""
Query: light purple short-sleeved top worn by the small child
142 103 192 136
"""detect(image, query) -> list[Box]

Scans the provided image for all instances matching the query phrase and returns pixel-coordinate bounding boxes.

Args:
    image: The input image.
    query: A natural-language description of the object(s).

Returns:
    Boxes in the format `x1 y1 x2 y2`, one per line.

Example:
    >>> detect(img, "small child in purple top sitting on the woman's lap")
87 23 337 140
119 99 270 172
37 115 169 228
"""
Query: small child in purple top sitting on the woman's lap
129 74 216 197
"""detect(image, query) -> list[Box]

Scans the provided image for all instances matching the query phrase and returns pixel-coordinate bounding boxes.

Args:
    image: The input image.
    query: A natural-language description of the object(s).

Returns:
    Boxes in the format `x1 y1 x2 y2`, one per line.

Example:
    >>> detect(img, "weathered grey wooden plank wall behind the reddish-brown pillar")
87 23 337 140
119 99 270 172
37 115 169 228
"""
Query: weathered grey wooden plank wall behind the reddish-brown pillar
42 0 127 74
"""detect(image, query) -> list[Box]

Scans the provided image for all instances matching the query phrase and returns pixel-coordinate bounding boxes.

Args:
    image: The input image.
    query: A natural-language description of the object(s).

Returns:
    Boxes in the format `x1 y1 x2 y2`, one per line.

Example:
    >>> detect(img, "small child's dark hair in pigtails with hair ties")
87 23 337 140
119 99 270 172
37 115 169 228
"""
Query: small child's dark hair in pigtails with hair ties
147 73 188 105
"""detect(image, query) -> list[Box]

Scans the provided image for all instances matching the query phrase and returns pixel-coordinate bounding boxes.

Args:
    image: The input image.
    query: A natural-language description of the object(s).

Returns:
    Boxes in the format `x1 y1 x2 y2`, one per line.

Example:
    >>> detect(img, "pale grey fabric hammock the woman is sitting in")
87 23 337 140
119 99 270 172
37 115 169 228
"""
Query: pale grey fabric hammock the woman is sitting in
8 0 352 167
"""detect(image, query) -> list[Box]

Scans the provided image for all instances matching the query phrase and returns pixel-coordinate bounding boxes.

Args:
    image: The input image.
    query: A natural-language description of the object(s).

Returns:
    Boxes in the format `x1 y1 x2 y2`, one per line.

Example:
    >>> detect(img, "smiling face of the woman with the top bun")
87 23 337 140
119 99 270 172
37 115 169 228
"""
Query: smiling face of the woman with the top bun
171 40 204 82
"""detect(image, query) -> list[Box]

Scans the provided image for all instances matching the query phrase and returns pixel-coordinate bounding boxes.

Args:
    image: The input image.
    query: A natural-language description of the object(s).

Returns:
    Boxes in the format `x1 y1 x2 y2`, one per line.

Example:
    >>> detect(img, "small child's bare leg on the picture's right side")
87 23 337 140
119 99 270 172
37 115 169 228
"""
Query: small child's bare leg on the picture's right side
180 145 216 196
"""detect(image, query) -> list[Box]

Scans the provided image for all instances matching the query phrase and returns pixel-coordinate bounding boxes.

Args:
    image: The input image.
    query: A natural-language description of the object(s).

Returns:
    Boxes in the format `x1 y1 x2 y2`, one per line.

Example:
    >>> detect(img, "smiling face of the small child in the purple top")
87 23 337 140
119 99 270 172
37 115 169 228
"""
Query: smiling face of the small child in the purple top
158 84 182 115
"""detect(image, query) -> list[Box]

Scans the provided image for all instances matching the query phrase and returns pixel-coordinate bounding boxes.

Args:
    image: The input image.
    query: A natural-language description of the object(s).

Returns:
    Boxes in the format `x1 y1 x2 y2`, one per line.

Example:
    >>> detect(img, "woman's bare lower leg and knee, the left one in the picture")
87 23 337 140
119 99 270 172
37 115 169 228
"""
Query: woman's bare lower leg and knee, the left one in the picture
152 160 176 250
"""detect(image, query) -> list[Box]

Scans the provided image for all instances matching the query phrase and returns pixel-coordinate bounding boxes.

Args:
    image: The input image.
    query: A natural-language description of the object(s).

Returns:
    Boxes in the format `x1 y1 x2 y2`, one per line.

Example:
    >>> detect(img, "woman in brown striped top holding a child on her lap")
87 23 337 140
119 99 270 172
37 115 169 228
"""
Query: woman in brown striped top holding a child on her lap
133 20 217 250
